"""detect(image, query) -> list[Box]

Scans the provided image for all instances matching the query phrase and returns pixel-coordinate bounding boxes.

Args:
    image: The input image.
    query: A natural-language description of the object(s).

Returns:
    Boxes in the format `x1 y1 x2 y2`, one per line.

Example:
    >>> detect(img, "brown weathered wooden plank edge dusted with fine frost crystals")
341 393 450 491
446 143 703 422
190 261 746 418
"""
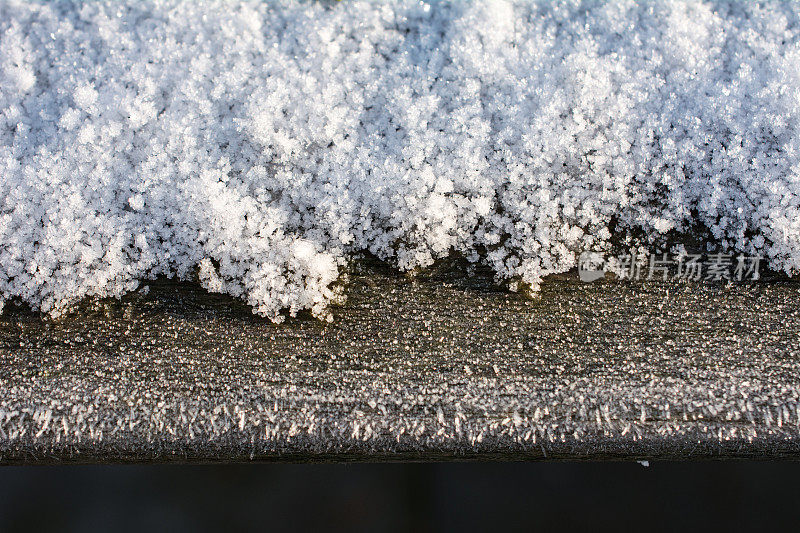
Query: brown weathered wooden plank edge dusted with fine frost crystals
0 261 800 463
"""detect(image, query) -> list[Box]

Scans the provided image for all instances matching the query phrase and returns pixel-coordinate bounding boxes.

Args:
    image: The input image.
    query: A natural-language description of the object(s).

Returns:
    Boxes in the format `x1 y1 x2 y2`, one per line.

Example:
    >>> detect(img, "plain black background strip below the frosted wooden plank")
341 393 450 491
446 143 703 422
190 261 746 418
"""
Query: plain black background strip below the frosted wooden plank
0 461 800 531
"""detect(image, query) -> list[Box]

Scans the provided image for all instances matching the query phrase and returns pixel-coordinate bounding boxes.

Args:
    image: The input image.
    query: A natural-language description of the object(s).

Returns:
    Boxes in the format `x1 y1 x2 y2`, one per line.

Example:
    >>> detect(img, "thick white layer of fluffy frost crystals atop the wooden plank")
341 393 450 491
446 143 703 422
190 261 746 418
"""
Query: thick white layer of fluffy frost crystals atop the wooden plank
0 0 800 319
